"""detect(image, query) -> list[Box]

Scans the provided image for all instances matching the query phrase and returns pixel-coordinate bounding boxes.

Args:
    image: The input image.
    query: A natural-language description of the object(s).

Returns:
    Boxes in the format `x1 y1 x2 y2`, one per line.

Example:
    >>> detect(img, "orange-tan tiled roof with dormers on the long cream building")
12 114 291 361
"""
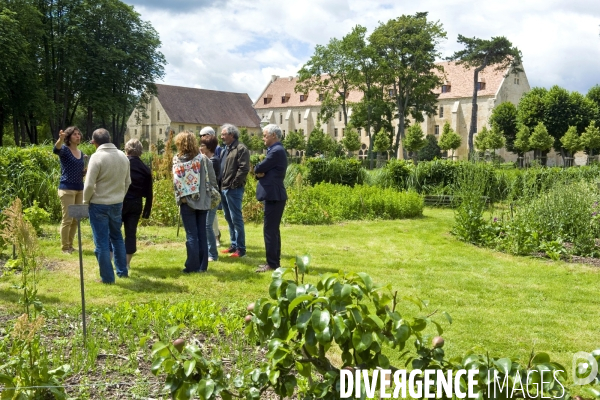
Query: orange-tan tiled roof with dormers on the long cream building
254 62 504 109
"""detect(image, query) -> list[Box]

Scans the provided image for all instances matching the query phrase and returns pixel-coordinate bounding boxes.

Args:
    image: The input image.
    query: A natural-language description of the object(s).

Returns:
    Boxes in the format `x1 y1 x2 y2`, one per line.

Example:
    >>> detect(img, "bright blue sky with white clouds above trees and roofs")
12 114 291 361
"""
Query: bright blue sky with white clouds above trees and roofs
124 0 600 100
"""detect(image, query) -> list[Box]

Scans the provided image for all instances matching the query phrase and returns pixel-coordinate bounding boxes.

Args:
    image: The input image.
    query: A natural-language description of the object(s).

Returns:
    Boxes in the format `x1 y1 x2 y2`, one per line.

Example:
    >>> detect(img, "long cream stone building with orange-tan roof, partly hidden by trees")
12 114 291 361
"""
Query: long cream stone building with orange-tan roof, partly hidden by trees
254 62 530 160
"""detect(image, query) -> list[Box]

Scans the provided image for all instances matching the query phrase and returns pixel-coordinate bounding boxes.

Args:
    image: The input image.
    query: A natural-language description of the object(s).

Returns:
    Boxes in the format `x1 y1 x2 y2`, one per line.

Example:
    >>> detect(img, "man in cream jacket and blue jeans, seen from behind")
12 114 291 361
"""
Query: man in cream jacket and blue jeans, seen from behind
83 129 131 283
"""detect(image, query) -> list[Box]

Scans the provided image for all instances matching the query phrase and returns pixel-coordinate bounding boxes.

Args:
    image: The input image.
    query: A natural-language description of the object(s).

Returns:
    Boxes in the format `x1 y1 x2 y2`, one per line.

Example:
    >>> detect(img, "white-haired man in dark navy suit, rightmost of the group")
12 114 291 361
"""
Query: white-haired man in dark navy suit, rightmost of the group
254 124 287 272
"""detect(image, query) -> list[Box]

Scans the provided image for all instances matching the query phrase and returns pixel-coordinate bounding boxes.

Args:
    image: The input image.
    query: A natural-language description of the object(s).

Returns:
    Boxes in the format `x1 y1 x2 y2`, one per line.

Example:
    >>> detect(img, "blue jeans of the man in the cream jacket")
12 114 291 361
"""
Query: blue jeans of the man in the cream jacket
89 203 128 283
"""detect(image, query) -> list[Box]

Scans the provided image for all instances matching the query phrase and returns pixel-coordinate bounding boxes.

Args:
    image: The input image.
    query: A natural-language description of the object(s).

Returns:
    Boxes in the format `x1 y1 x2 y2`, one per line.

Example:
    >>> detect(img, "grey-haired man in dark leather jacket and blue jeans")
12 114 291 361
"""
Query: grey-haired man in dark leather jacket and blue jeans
221 124 250 257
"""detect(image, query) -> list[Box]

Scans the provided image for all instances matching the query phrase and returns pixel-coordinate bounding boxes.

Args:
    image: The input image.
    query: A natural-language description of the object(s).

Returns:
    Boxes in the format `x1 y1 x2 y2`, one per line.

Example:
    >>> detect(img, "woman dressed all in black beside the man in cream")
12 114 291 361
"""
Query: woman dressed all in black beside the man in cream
122 139 152 269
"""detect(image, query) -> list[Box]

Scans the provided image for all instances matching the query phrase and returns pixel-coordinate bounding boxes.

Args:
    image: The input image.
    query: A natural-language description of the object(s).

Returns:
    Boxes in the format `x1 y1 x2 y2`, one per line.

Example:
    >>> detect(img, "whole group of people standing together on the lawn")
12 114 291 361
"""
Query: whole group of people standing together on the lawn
53 124 287 283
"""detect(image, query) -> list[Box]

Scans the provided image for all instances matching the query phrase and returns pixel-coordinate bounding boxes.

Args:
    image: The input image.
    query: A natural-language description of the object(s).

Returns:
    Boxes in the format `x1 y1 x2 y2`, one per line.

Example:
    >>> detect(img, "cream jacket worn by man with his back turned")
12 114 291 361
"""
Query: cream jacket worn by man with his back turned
83 143 131 205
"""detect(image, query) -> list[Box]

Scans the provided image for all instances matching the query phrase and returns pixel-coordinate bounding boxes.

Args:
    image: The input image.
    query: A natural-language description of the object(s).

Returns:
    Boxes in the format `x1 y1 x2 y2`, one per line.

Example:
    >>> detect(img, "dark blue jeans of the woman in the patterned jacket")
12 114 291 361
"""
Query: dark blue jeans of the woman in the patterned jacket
179 203 208 272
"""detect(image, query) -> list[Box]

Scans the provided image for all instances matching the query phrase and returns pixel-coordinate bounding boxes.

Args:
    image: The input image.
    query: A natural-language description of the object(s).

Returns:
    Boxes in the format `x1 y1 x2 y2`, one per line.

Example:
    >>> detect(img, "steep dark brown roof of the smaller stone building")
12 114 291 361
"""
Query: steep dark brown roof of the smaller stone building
156 84 260 128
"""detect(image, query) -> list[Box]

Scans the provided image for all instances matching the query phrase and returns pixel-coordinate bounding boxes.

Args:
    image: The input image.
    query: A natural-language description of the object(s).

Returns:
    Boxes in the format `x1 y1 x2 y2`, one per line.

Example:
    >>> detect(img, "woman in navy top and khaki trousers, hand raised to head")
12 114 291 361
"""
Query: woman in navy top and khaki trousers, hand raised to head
52 126 87 254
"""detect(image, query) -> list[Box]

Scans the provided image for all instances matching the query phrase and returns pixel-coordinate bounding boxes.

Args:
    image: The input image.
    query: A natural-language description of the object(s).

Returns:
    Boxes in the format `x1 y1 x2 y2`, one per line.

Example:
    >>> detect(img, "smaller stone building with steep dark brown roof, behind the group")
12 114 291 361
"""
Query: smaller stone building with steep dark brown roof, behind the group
125 84 260 145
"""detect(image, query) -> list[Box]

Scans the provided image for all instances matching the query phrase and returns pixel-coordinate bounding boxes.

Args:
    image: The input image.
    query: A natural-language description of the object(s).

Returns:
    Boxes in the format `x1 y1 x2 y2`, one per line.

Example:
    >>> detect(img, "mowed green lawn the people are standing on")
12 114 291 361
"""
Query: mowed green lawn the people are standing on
0 209 600 368
